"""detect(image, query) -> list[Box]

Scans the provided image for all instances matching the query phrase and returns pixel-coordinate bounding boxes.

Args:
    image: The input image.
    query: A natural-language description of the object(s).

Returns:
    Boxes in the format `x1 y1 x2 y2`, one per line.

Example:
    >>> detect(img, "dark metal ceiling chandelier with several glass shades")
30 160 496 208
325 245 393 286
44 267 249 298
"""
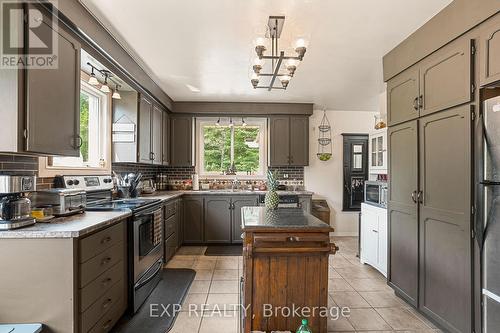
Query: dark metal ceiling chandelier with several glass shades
251 16 307 91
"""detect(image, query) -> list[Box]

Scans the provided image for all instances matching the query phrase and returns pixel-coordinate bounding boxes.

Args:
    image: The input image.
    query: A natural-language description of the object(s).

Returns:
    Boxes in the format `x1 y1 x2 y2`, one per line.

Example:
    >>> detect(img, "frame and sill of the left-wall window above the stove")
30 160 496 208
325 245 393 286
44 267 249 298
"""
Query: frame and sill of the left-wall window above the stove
38 72 112 177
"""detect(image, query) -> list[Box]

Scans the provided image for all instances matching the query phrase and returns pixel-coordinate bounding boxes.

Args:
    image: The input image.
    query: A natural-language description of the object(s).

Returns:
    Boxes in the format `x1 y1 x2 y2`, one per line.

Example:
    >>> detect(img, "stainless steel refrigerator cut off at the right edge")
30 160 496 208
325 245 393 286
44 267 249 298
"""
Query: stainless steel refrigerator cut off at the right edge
476 97 500 333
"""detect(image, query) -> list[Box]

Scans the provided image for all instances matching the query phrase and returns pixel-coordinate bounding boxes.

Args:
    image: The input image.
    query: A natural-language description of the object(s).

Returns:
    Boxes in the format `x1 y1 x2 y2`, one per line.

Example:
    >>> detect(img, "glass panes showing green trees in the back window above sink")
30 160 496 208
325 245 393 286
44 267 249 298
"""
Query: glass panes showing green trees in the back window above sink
203 125 261 174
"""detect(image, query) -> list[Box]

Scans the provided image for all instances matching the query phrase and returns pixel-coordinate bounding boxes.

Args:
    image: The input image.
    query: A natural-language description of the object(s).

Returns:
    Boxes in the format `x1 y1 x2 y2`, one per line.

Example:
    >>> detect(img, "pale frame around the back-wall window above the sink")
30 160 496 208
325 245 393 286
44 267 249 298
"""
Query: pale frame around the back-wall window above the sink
195 117 268 179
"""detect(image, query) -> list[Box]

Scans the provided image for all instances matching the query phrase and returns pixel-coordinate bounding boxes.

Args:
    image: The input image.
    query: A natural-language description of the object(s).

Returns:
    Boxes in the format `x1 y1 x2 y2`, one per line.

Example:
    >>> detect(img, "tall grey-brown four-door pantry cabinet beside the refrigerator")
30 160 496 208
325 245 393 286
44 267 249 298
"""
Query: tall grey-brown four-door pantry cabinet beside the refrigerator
387 38 475 332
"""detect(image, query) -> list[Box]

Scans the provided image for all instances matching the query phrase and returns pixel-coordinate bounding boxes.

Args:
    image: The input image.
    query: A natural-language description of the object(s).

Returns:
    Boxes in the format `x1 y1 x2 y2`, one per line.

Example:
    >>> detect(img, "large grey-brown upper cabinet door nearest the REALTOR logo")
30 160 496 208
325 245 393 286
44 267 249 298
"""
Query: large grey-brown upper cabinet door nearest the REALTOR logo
24 5 81 157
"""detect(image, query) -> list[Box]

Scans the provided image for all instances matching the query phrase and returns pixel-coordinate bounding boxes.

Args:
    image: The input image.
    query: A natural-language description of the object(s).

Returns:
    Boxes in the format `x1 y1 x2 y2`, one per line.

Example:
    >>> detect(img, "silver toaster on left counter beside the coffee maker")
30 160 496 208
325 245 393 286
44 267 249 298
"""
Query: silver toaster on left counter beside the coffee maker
32 188 87 216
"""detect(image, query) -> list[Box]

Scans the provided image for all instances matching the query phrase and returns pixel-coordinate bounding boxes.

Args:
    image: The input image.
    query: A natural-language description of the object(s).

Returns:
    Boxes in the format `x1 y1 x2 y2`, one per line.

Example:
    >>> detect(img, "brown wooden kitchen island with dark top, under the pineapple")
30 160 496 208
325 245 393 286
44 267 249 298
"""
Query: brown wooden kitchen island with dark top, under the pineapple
241 207 337 333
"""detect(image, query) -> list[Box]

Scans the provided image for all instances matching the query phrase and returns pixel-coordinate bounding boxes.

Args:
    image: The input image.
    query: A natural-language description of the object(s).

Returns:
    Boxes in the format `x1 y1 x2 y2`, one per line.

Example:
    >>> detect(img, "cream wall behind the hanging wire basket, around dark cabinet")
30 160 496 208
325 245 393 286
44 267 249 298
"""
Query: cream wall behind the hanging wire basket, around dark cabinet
304 110 377 236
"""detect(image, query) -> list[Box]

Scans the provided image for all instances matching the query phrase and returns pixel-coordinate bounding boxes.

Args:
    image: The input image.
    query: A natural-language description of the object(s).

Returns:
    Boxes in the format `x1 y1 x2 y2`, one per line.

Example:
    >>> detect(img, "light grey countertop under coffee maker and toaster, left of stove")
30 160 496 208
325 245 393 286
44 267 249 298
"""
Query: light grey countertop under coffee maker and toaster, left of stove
0 210 132 239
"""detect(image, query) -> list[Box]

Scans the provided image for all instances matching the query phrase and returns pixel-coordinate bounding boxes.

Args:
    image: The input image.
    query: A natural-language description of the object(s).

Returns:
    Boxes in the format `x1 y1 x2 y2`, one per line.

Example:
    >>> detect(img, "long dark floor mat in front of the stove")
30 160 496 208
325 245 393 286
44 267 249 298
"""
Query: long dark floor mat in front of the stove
112 268 196 333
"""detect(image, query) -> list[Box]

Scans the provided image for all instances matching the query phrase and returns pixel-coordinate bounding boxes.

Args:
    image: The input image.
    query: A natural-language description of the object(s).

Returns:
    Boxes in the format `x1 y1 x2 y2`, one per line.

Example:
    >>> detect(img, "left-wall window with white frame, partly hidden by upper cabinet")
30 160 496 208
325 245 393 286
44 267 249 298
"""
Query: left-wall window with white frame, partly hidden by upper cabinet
41 80 111 173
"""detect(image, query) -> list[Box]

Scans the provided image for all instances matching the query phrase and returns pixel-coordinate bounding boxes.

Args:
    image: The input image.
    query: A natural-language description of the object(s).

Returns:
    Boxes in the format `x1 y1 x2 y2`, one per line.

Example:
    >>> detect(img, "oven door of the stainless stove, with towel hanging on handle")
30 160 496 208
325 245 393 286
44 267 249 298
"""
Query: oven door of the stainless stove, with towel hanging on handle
133 207 163 283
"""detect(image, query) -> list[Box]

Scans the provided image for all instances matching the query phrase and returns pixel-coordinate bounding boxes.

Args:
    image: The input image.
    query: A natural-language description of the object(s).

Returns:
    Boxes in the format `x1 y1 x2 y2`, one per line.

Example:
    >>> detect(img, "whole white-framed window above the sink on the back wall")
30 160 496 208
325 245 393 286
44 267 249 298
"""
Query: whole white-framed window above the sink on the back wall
197 118 266 176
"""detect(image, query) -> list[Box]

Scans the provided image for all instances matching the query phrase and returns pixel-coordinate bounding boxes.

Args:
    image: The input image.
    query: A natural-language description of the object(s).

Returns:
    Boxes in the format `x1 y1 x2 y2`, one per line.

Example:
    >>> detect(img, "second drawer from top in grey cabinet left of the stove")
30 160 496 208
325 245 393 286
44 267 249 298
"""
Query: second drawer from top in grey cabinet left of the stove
80 242 125 288
